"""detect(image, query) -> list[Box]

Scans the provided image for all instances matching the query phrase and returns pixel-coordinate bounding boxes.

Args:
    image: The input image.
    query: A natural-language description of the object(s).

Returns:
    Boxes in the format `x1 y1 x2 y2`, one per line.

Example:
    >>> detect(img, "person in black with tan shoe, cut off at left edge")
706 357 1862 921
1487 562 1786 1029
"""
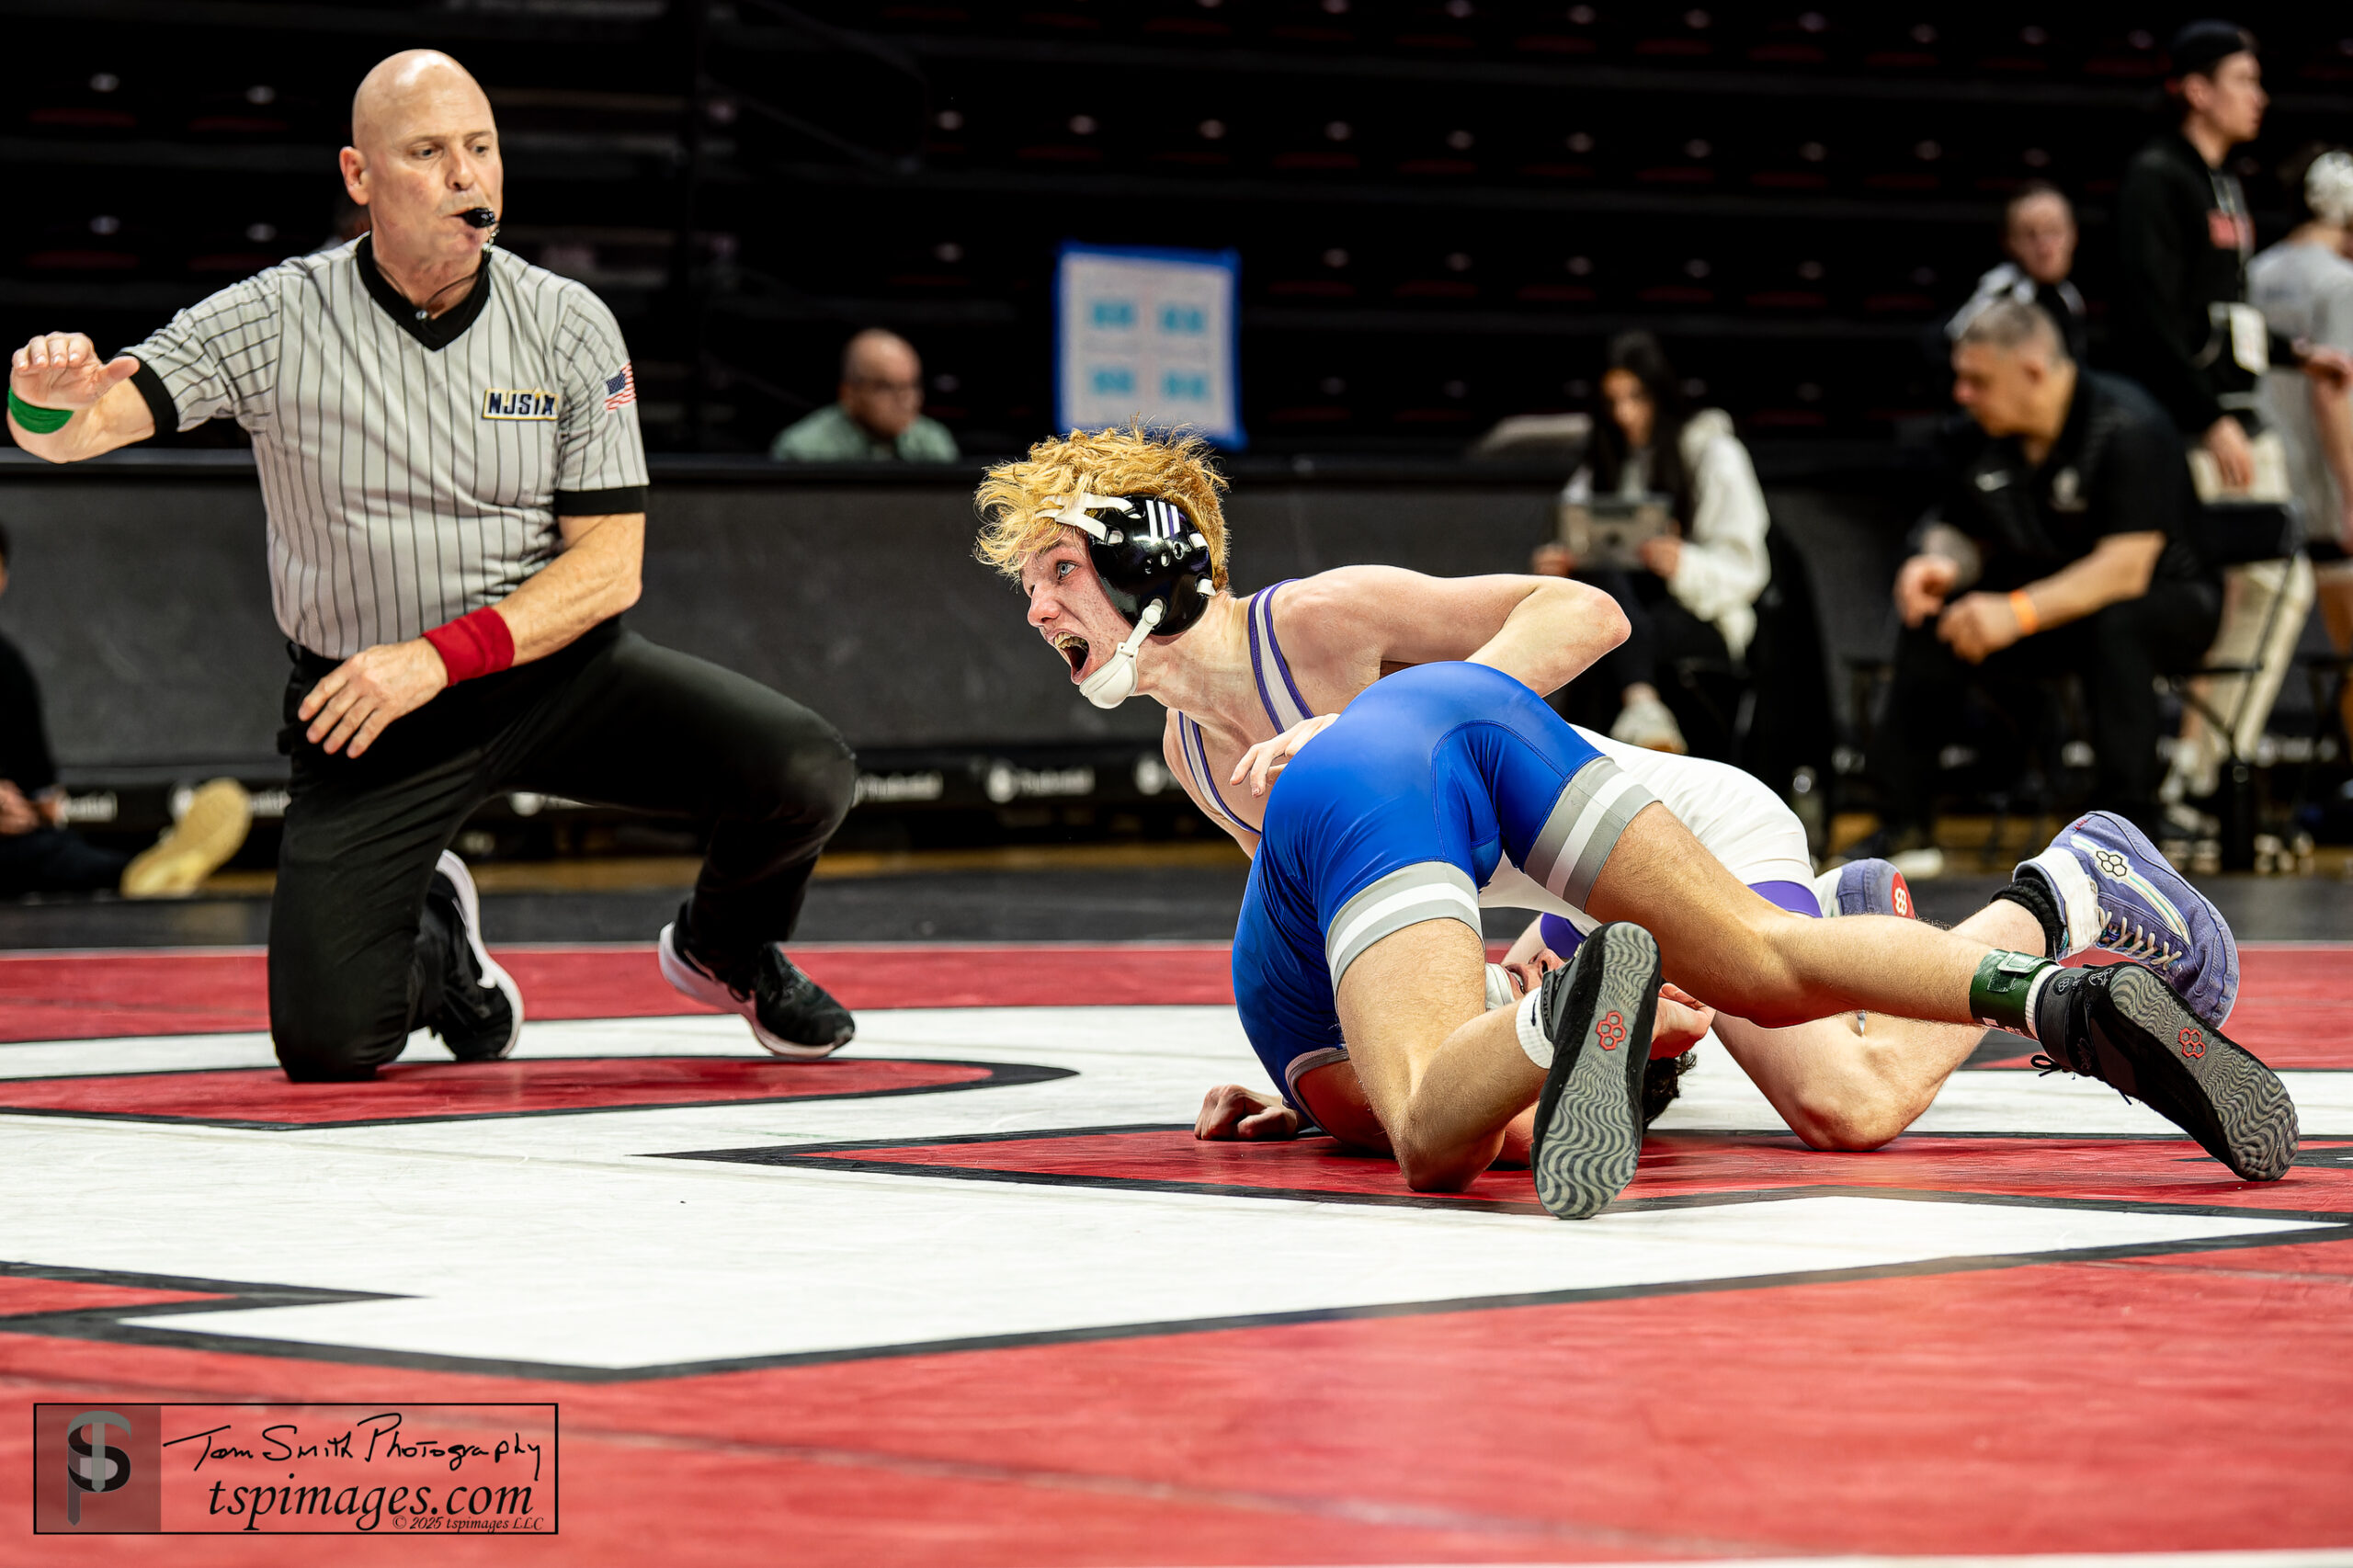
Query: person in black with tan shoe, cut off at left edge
0 528 252 897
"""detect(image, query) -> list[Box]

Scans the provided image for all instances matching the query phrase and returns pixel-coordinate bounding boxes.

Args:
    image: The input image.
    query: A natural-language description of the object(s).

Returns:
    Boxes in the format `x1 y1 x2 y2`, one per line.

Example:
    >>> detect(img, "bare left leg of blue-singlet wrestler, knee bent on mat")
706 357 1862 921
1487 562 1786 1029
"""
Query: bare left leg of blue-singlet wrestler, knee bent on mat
1335 921 1543 1191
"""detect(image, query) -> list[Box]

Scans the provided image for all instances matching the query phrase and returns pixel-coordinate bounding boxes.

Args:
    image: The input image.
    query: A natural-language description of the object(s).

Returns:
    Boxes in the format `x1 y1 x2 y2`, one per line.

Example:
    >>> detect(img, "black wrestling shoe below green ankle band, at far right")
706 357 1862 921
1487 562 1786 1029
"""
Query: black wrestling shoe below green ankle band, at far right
2033 963 2297 1182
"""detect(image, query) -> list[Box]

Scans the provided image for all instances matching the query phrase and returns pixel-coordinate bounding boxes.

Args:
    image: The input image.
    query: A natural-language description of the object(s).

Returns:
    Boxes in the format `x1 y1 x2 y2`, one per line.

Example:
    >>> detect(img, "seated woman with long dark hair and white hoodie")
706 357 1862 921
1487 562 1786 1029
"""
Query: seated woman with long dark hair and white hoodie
1532 332 1772 760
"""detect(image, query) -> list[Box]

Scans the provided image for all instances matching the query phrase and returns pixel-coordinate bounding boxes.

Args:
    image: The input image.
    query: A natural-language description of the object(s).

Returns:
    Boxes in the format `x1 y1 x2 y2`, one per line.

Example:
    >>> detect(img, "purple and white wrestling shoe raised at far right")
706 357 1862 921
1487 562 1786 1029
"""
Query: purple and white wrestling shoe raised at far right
2017 812 2238 1028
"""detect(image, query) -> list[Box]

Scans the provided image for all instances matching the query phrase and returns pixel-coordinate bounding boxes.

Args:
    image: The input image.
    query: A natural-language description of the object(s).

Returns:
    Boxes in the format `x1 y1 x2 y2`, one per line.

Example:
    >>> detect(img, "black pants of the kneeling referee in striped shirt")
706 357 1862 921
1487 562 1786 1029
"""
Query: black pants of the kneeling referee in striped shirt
270 621 857 1081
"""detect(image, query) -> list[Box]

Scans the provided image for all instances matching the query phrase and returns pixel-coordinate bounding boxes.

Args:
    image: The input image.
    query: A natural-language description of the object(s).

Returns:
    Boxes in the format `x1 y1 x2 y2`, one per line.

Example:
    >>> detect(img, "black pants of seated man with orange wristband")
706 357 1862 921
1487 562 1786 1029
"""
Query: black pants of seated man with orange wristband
1875 582 2222 834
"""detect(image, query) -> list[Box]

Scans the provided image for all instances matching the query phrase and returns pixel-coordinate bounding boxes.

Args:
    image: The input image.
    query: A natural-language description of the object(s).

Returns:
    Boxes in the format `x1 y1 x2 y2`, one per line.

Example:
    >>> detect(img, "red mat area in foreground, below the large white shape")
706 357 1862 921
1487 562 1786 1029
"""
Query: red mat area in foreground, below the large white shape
0 1244 2353 1568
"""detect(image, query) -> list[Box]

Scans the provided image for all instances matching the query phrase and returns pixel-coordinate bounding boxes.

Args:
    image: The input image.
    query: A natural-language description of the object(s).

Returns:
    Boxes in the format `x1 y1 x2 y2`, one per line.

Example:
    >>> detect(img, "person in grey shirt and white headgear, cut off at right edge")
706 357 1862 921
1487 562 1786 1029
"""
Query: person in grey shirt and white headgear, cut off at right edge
2247 146 2353 734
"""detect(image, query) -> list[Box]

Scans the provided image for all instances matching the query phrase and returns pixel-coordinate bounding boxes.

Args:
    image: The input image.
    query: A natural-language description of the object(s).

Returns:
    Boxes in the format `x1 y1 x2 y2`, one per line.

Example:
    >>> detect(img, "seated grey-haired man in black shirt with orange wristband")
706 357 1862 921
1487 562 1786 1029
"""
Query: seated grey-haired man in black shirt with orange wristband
1880 301 2222 847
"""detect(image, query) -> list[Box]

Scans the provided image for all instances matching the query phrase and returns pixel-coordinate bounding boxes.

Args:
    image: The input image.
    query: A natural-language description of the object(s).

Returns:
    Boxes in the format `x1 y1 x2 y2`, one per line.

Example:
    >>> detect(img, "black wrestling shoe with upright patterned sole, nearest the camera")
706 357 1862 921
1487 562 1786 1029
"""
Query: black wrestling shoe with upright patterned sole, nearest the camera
1527 921 1659 1220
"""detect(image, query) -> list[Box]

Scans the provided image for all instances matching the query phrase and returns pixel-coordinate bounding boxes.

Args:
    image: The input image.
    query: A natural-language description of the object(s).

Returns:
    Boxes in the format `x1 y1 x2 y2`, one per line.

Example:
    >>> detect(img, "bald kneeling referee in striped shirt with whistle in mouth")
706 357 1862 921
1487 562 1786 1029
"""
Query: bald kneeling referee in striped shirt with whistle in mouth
7 50 854 1081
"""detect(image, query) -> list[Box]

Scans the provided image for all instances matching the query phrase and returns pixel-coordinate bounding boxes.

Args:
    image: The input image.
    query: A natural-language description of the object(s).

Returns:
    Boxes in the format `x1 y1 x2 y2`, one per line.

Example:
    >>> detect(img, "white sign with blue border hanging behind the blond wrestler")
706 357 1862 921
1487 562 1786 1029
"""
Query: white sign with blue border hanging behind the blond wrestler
1054 244 1245 448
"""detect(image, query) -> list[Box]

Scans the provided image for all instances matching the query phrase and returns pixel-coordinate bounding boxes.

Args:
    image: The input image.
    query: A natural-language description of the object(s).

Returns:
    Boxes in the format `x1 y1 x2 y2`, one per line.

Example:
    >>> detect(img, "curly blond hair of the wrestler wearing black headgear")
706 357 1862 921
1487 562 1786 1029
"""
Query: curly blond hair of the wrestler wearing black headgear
972 422 1226 588
